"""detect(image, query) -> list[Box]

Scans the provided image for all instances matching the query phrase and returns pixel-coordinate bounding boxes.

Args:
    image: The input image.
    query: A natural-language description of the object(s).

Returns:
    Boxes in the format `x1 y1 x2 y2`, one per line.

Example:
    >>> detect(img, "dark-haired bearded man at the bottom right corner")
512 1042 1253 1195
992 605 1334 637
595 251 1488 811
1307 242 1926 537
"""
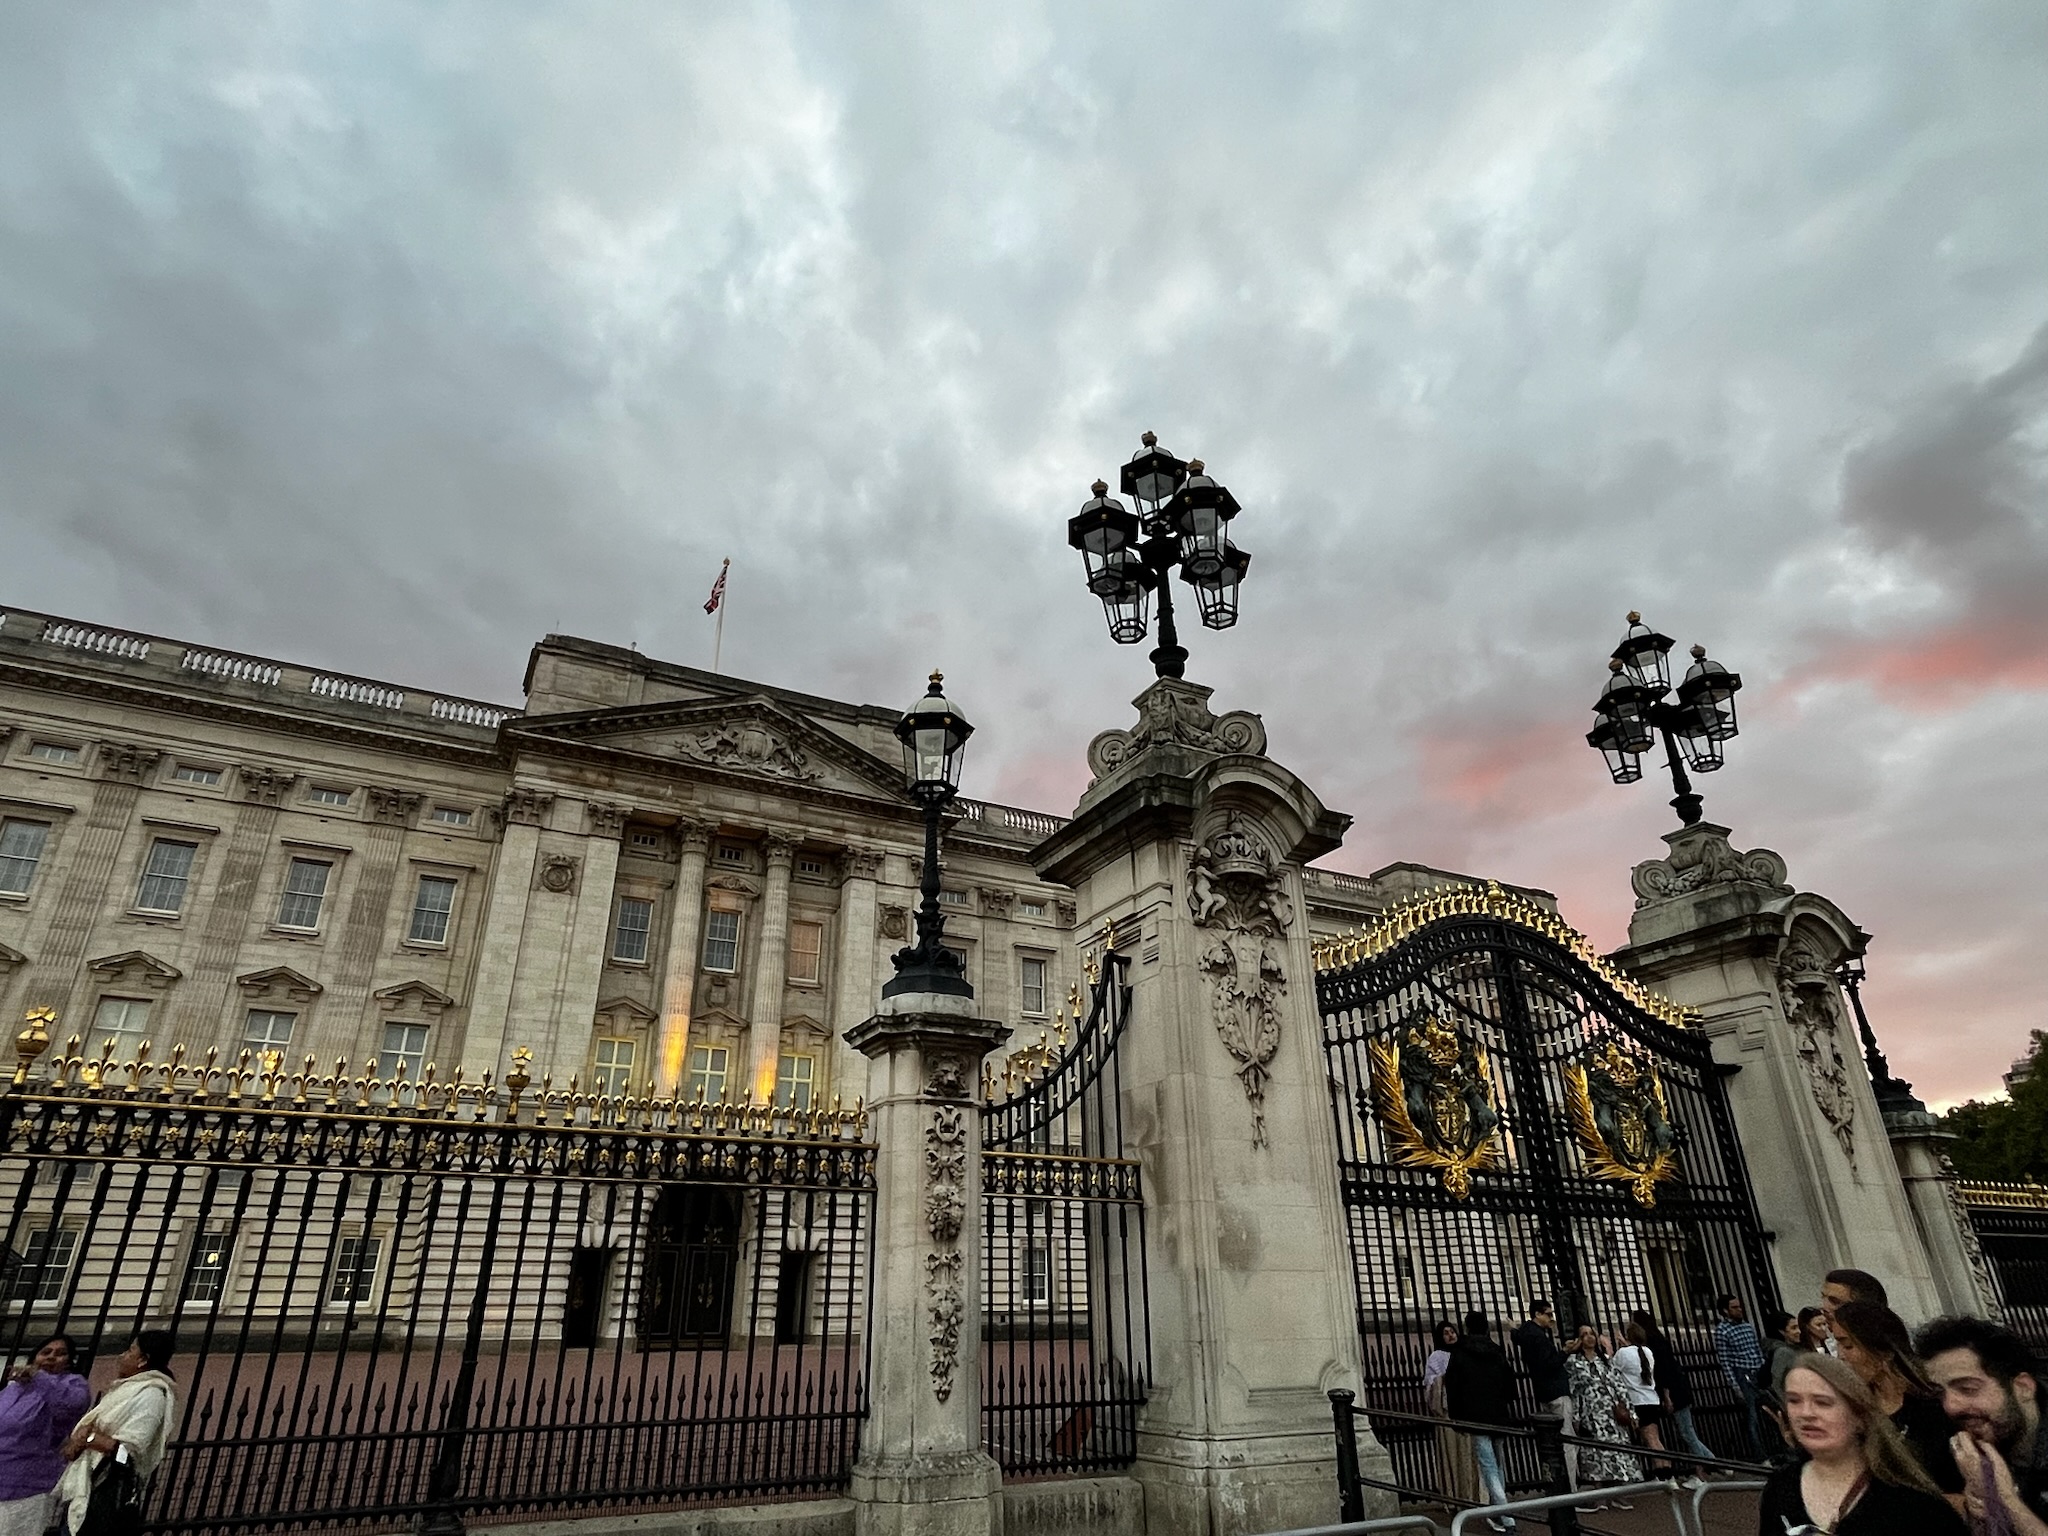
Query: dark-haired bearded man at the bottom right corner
1913 1317 2048 1536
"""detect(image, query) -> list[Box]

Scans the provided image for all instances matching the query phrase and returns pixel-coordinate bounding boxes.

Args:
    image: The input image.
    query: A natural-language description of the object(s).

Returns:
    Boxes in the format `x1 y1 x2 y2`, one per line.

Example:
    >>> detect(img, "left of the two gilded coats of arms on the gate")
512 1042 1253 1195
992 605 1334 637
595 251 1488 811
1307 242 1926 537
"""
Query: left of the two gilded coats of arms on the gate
1360 1014 1501 1200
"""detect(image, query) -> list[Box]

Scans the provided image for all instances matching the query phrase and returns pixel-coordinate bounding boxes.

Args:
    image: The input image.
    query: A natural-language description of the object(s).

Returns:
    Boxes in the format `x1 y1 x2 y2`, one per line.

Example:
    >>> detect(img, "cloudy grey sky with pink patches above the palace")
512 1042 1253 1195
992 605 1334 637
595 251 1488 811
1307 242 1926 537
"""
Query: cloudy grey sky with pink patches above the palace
0 0 2048 1100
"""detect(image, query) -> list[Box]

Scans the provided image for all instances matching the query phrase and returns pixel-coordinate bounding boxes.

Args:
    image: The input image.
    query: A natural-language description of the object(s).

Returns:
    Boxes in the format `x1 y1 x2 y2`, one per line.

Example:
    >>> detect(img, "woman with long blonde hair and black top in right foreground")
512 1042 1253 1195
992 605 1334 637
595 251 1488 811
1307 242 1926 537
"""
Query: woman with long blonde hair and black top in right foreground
1757 1354 1968 1536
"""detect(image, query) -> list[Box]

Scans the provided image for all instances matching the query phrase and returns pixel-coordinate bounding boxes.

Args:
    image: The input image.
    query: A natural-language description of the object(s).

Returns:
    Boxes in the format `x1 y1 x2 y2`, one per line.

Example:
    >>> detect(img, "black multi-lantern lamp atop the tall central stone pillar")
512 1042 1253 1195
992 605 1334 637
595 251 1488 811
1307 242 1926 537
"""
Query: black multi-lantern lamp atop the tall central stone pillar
1067 432 1251 678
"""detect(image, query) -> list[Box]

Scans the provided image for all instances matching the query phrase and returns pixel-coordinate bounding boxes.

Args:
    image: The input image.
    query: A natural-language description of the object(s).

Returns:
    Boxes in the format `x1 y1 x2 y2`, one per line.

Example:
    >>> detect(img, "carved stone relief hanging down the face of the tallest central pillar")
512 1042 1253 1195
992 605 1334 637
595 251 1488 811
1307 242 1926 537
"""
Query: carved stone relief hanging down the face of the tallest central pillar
1188 811 1288 1147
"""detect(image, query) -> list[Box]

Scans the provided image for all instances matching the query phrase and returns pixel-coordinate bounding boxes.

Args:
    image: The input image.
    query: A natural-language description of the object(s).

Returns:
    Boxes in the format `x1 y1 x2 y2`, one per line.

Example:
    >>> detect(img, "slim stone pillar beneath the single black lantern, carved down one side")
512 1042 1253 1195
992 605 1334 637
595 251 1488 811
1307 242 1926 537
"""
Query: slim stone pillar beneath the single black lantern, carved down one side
846 993 1010 1536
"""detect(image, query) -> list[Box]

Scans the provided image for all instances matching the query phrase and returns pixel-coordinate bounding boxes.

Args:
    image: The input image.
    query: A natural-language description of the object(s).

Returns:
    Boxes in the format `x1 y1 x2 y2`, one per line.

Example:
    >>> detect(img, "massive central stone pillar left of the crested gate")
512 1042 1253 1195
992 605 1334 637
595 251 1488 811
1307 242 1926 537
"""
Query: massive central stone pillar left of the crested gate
1032 680 1391 1536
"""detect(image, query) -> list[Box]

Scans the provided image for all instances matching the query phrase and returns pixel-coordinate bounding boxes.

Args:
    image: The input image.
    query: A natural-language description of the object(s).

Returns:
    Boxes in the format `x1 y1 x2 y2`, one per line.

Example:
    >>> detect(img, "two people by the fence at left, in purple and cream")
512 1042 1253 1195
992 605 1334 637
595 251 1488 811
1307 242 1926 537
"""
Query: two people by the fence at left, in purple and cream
0 1329 178 1536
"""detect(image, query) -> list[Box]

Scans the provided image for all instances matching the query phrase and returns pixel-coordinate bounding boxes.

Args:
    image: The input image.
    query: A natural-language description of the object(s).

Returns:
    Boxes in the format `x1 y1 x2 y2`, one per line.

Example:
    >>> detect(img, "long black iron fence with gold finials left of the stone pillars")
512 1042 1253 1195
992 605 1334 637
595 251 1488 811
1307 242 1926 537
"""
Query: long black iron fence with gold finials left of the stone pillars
0 1042 872 1532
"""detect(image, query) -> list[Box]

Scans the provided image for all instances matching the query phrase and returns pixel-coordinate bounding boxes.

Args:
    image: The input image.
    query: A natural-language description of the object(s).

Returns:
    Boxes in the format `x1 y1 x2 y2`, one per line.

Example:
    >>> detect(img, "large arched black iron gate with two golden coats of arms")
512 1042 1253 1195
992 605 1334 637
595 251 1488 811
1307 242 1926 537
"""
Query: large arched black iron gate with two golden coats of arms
1317 883 1778 1487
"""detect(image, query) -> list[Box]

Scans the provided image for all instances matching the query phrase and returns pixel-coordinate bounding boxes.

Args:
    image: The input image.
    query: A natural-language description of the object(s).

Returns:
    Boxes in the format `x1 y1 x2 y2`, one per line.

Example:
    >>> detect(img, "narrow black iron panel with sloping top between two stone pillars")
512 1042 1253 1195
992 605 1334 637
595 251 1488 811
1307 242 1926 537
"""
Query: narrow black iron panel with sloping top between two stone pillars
981 944 1151 1473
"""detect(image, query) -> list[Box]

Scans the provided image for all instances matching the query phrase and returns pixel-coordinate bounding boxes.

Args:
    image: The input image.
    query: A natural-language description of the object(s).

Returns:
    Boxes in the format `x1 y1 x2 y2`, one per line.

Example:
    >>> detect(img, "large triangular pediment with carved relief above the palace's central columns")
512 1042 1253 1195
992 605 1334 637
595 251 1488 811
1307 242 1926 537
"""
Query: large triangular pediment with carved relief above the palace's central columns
506 696 909 803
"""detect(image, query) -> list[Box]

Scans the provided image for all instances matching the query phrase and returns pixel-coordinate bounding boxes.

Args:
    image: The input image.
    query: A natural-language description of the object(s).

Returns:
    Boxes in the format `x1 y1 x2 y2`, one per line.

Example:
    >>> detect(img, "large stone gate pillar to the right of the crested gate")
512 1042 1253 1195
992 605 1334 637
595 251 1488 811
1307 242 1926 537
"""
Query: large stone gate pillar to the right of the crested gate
1614 821 1942 1317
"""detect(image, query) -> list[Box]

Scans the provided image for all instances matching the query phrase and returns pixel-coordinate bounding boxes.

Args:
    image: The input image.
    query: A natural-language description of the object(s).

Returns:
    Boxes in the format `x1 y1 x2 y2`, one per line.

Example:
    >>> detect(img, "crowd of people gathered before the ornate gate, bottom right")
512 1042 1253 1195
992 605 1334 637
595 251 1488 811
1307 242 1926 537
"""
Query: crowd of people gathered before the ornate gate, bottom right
1425 1270 2048 1536
